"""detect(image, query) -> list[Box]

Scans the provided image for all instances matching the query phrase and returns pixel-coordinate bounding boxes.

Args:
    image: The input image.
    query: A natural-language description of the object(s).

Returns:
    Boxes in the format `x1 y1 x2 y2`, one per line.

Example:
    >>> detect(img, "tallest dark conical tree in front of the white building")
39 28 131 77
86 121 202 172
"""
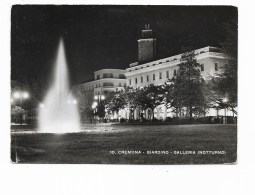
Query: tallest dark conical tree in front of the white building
170 48 206 118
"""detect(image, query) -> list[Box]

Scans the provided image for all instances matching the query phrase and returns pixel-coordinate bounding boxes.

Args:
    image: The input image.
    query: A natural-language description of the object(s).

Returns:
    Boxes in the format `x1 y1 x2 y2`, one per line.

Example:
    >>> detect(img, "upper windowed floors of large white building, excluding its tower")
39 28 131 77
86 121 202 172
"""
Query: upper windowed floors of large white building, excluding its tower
125 46 227 88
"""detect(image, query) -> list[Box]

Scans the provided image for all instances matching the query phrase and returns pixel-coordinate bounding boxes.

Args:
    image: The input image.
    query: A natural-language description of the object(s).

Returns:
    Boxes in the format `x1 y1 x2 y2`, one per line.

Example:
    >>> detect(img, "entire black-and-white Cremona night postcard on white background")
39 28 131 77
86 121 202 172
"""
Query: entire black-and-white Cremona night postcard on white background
10 5 238 164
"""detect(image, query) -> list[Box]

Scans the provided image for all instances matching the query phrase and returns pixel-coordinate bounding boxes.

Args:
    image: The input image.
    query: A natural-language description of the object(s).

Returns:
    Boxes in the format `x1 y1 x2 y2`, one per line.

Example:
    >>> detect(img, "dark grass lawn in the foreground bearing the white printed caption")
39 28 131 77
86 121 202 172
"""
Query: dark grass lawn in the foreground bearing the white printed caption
11 125 237 164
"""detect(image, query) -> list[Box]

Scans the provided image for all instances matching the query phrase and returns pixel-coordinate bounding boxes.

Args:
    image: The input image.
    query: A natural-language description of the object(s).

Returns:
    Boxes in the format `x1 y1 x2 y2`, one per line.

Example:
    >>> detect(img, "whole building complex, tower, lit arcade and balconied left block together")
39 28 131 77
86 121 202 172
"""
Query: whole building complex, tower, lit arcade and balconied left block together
73 24 231 120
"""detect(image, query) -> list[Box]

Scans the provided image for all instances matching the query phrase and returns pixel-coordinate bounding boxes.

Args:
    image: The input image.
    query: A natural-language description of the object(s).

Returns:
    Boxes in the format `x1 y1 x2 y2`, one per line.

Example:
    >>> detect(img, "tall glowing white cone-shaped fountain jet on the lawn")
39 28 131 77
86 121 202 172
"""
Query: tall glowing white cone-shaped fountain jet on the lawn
39 40 80 133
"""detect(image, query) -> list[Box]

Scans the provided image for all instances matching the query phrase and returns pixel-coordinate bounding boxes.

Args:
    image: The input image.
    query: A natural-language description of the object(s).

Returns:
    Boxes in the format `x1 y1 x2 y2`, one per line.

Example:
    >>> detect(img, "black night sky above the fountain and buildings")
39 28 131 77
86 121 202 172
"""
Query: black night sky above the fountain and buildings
11 5 237 86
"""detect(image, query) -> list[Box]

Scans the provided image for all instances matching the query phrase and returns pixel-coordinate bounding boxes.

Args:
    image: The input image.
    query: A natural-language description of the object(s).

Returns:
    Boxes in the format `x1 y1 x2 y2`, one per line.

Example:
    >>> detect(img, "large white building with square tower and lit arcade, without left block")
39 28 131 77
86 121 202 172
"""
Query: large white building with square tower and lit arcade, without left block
122 25 230 120
